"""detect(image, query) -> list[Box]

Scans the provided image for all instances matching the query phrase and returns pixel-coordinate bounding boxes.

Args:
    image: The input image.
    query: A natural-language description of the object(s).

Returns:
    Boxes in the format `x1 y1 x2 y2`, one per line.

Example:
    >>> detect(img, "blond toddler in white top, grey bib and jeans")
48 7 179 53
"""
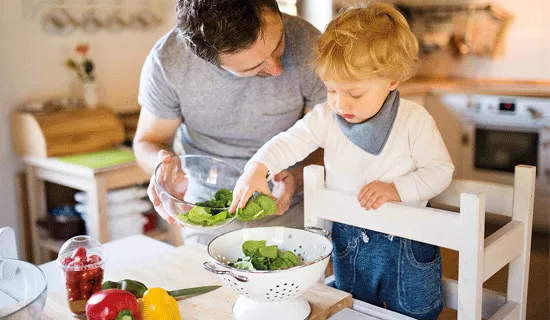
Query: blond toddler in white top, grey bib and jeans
230 3 454 319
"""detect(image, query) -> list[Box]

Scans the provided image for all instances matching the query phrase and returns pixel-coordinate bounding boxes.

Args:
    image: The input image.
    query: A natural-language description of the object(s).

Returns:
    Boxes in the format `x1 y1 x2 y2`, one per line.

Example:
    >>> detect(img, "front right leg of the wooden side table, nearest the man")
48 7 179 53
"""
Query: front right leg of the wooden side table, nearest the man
86 176 109 243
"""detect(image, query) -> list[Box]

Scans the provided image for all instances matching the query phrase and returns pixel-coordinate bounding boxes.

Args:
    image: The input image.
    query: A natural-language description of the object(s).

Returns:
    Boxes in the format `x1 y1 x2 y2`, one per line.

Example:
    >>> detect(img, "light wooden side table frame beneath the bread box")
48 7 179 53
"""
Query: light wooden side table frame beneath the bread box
23 157 183 264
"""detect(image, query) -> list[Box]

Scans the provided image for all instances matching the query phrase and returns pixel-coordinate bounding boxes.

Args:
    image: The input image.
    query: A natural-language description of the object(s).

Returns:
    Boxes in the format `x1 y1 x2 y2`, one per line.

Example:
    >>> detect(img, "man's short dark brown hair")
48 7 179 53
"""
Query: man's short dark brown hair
177 0 281 65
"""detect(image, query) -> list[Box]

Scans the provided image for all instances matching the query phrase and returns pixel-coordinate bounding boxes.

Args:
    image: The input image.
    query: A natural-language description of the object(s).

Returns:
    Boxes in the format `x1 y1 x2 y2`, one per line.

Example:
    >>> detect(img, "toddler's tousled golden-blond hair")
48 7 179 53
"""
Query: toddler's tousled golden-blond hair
313 3 418 82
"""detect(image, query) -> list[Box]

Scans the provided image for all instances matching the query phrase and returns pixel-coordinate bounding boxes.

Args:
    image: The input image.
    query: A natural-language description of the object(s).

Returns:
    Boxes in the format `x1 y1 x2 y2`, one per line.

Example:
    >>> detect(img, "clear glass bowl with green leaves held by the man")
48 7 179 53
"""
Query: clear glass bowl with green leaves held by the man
154 155 242 229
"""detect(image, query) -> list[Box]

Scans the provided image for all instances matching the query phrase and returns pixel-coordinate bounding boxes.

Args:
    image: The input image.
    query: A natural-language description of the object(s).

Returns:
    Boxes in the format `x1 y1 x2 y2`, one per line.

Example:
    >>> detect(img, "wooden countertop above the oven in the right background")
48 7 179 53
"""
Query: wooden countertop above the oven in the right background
399 78 550 98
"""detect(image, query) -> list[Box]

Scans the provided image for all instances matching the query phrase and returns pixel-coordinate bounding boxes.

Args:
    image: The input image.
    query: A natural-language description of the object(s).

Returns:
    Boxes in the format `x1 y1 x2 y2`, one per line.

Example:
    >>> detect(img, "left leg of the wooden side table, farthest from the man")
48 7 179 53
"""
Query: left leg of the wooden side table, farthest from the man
25 165 47 264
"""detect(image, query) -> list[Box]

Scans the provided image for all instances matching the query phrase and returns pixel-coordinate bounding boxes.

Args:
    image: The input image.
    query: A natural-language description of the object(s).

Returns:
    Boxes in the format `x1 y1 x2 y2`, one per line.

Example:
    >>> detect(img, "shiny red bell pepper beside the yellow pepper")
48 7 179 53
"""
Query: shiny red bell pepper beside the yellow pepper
86 289 140 320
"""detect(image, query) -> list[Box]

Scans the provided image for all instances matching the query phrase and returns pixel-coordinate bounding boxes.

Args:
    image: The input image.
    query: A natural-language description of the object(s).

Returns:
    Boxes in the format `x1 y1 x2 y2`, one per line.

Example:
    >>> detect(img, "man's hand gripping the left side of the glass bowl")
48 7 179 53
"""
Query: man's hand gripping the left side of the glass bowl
147 150 187 224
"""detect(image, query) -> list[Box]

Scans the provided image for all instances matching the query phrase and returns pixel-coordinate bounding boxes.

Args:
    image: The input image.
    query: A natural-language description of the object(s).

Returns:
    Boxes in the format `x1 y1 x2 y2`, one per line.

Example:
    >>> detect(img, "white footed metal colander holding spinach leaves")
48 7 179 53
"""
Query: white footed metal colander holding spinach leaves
204 227 332 320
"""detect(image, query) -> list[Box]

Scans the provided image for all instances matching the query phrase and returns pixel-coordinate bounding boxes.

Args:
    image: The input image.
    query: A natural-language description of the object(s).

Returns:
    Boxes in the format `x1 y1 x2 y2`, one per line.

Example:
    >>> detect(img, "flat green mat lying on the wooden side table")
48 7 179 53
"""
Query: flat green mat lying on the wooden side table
59 149 136 169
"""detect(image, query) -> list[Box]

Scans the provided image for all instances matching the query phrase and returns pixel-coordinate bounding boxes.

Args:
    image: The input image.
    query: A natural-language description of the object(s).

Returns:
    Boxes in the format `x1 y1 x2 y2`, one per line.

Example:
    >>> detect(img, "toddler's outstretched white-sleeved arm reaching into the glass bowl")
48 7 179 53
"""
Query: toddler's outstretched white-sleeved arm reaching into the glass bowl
229 104 332 212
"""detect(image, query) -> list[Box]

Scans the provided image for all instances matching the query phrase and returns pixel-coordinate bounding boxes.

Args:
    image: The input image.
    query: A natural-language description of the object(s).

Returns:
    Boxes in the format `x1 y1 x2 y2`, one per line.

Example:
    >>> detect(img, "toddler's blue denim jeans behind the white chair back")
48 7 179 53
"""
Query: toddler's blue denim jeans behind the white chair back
332 223 443 320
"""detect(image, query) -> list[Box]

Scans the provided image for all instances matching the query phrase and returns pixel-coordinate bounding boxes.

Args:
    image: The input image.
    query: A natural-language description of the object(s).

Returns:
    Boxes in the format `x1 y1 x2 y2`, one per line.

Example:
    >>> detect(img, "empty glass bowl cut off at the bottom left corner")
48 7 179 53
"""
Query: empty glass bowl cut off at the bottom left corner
0 258 48 320
